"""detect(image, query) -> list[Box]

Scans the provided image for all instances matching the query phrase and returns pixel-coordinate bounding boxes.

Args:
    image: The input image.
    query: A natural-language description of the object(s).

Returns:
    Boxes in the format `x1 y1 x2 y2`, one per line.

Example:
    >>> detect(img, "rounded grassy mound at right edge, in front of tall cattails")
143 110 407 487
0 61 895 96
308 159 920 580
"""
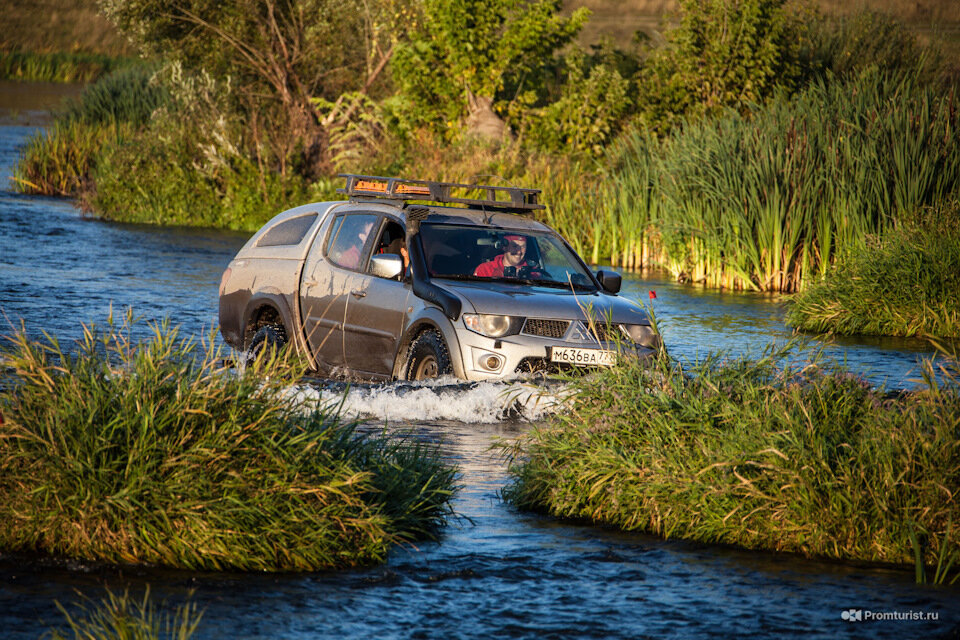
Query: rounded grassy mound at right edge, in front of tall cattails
787 202 960 338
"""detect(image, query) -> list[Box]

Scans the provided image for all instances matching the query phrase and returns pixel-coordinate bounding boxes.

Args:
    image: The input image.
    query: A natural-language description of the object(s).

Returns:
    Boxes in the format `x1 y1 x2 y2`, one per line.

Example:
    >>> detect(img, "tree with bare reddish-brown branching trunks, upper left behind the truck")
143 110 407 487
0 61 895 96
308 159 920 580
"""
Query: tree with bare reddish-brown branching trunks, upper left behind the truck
100 0 404 175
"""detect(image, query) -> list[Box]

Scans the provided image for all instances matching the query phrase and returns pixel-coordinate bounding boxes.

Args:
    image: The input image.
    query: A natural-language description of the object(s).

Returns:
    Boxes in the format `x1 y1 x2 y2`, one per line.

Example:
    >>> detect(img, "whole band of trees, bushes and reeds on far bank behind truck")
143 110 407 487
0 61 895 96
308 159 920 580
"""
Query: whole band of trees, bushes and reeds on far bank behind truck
16 0 960 292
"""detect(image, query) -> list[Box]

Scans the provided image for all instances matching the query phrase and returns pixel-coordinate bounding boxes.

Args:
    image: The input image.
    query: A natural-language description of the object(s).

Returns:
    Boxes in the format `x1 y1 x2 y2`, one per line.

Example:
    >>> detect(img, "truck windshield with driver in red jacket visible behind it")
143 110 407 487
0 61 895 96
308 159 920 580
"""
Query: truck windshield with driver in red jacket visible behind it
420 223 596 291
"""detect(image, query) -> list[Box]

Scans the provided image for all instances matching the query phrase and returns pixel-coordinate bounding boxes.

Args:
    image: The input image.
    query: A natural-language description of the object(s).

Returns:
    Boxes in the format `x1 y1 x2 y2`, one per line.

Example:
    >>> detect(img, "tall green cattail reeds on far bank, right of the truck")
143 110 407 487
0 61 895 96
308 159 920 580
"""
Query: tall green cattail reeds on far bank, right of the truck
580 71 960 291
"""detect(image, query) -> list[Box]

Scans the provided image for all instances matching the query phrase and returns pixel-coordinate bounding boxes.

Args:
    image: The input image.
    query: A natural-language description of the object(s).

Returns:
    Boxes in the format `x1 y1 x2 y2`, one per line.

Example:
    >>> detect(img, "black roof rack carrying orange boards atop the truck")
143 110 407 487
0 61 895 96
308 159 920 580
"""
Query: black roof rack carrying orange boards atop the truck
337 173 546 213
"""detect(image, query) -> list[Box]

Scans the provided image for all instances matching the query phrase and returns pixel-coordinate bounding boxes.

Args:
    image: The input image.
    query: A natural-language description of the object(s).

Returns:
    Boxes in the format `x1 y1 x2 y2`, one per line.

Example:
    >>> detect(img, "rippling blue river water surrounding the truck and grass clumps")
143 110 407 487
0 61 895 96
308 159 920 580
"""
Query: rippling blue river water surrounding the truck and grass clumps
0 114 960 639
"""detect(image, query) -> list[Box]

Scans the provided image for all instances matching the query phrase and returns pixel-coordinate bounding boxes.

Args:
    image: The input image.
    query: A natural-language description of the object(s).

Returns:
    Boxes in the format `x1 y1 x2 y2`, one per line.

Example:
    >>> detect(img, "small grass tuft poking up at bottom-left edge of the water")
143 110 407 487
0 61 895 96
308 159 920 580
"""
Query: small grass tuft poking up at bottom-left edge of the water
44 588 203 640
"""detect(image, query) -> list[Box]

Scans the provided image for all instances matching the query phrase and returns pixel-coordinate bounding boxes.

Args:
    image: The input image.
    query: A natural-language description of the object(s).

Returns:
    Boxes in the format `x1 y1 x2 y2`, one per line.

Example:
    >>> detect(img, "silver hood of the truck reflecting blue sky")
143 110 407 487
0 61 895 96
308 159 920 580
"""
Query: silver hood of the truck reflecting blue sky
434 278 650 324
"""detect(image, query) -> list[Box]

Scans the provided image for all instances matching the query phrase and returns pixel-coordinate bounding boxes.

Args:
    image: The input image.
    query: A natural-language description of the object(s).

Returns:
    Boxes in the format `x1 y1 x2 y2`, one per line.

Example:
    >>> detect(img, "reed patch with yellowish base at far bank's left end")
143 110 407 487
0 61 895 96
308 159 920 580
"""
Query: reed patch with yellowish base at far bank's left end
13 65 168 196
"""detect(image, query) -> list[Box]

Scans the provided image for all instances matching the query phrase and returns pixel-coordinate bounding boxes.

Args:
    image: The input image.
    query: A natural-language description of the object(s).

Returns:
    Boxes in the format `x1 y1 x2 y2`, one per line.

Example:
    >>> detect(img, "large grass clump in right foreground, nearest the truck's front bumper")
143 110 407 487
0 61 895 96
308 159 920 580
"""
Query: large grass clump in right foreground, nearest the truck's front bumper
504 349 960 582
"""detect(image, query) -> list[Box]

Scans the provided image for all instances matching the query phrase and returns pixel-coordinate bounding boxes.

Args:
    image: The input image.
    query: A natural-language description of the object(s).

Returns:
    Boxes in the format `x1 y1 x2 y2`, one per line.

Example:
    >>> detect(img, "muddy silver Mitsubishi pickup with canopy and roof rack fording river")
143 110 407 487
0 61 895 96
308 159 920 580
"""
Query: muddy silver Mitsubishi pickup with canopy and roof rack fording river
220 175 660 380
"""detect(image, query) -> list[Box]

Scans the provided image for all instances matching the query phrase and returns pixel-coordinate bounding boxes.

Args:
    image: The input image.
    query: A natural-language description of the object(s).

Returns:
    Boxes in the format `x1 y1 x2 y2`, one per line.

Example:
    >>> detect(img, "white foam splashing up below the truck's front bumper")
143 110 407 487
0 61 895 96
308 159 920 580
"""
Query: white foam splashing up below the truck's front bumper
284 377 567 423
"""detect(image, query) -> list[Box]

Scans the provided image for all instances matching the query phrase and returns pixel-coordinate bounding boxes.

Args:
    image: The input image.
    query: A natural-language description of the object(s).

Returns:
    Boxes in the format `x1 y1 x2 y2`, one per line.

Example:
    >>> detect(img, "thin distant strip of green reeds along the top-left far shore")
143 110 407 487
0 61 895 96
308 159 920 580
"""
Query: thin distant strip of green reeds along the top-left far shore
0 51 137 82
